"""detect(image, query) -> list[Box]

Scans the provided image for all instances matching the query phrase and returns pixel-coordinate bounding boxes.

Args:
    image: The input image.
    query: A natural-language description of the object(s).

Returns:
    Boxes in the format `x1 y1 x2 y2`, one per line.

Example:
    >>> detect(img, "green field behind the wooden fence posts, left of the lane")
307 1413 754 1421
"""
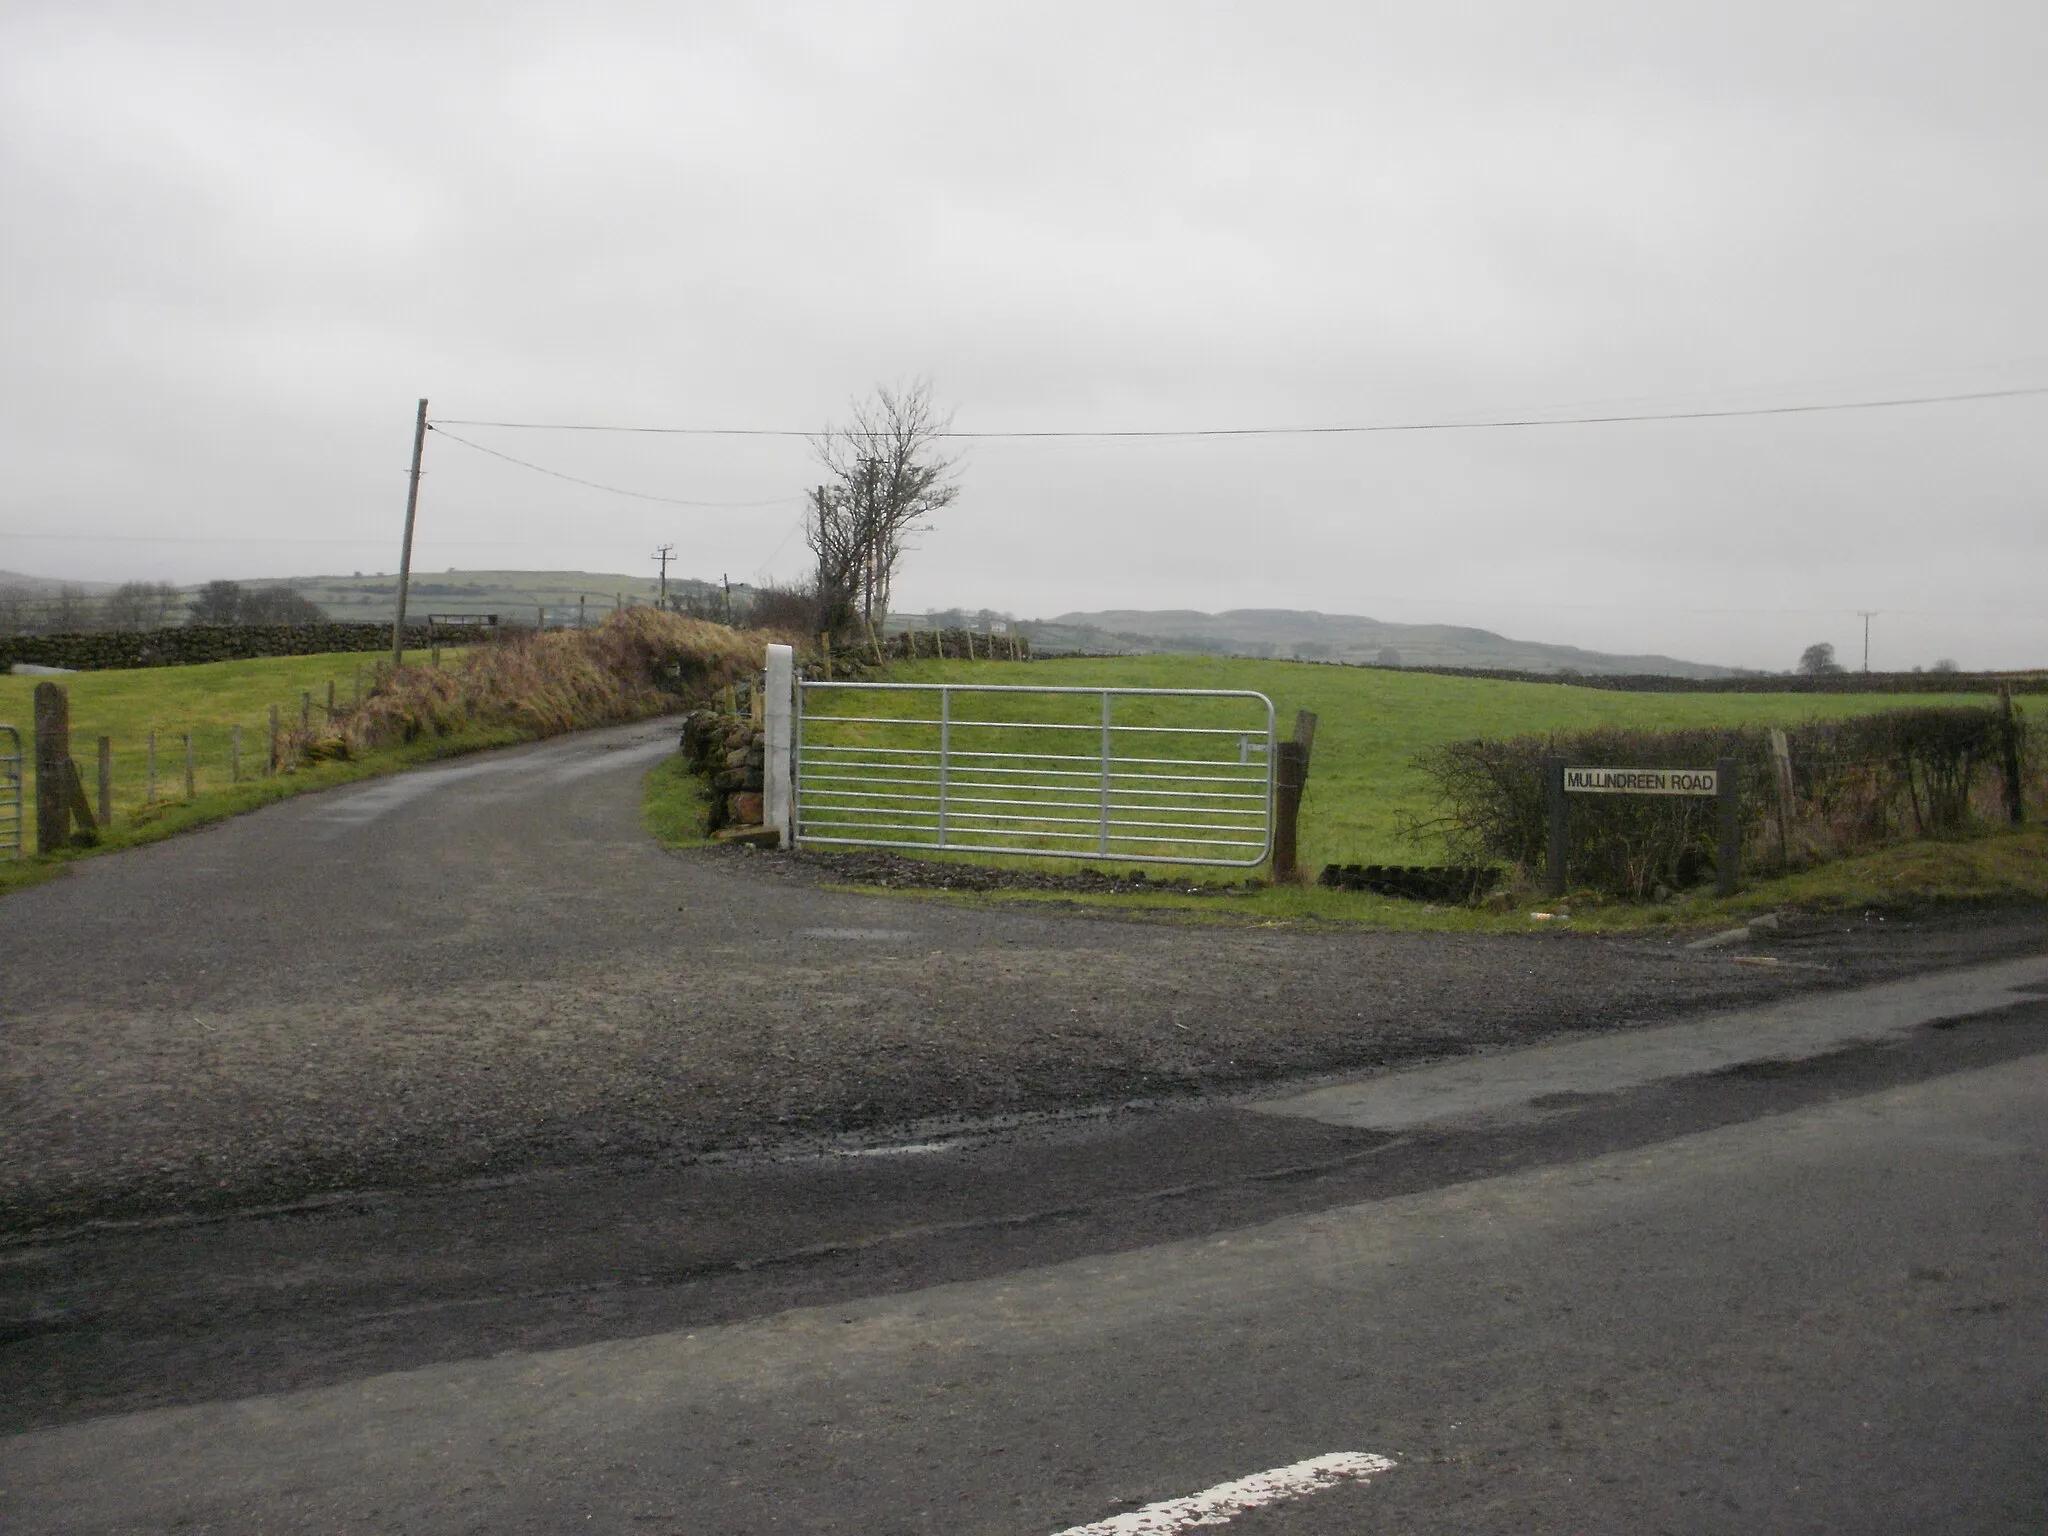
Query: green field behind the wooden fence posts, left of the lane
0 651 453 856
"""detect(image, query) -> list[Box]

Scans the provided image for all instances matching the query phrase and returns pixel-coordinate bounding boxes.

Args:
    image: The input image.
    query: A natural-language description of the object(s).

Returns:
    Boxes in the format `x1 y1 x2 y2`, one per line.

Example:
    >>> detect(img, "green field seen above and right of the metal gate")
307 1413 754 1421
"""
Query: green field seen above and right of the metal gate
868 655 1991 870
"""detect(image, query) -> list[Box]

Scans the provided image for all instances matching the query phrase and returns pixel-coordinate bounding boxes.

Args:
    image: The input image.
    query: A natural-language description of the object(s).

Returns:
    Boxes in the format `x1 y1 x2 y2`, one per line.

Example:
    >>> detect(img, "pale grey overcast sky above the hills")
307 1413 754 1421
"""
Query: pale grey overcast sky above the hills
0 0 2048 668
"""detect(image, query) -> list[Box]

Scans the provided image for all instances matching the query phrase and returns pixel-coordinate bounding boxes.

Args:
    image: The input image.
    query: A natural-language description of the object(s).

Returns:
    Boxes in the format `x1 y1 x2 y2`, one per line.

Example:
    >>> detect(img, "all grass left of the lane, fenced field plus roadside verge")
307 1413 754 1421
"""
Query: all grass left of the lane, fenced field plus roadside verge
0 651 495 891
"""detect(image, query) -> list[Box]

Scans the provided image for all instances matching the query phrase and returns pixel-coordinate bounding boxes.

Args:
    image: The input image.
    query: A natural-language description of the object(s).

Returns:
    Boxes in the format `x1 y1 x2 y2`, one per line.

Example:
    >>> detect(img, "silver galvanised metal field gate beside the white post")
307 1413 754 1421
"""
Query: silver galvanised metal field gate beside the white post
791 680 1276 868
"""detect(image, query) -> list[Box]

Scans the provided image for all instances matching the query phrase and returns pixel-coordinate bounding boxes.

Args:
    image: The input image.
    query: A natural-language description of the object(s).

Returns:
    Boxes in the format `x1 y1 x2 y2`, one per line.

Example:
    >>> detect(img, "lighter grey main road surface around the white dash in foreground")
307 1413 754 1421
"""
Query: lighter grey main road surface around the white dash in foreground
0 1006 2048 1536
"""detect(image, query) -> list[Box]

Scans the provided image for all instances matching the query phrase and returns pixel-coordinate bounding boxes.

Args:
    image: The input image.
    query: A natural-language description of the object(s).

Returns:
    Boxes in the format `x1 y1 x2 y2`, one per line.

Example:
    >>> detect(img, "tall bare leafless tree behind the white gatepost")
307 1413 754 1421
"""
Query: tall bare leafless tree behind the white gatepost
805 379 961 631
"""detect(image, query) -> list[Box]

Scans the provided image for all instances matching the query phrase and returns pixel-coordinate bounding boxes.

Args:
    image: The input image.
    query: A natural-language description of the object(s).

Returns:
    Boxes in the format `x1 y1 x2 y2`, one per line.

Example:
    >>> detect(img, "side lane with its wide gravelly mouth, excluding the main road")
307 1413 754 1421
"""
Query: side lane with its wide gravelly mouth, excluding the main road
0 723 2040 1231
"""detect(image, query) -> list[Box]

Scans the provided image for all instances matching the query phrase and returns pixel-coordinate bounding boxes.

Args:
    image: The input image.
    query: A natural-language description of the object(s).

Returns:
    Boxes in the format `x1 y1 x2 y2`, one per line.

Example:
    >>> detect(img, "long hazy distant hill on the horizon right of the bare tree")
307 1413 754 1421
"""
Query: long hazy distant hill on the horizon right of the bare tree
1020 608 1735 678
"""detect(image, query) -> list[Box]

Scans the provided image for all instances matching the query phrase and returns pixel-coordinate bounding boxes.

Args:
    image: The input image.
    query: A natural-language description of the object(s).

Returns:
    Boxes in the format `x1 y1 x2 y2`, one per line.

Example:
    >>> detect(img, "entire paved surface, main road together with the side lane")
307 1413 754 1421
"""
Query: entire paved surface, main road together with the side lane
0 729 2048 1536
